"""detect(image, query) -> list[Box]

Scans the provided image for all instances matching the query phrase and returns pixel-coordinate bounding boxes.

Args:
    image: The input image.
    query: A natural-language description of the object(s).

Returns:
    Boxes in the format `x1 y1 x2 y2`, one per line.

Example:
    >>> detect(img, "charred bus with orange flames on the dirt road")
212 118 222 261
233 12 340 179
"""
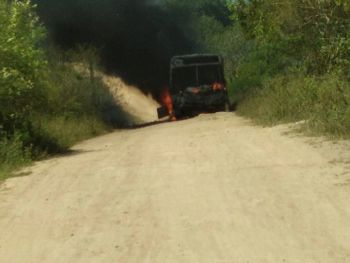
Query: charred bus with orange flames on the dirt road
158 54 230 120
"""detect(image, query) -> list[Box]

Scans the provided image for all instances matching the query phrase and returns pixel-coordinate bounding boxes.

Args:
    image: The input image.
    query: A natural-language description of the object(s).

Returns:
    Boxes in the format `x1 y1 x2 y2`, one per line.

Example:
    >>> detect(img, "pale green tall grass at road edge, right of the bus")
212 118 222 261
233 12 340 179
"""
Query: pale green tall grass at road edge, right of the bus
238 74 350 138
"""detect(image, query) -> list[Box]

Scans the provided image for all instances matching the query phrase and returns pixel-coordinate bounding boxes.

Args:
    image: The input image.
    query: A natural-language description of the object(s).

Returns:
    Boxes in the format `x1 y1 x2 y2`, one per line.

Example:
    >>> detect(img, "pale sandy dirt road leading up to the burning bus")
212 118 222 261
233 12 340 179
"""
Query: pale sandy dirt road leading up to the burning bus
0 113 350 263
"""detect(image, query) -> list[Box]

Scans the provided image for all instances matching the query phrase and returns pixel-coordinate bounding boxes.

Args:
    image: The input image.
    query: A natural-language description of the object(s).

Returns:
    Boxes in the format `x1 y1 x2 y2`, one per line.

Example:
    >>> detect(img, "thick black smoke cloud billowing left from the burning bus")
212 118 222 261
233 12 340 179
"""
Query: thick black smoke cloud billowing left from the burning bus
36 0 197 94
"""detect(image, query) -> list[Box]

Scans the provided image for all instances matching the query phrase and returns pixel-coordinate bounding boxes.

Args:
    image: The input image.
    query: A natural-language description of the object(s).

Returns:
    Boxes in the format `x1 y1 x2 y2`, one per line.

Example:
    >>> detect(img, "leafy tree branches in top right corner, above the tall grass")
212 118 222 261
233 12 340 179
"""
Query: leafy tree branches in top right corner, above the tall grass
231 0 350 74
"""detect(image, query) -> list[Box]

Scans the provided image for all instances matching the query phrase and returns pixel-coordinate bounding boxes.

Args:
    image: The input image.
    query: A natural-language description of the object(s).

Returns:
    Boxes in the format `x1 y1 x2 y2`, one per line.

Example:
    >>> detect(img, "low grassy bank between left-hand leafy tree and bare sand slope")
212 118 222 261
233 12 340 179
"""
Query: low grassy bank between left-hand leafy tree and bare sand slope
0 61 134 182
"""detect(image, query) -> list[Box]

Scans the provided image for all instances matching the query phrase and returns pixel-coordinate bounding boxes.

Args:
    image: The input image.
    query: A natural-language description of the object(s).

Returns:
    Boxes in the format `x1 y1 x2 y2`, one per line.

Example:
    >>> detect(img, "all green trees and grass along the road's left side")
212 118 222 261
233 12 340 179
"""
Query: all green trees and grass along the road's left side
0 0 129 180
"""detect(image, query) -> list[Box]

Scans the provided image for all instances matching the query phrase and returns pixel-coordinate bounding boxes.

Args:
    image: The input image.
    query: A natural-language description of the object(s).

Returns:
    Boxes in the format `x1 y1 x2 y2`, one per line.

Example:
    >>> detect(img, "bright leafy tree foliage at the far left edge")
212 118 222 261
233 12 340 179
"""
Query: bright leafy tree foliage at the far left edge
0 0 46 132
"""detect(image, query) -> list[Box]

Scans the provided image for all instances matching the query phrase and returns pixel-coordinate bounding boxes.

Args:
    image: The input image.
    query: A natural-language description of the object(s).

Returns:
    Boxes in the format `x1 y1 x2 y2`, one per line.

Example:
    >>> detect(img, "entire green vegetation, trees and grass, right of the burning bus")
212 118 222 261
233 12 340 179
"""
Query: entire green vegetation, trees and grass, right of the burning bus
170 0 350 138
